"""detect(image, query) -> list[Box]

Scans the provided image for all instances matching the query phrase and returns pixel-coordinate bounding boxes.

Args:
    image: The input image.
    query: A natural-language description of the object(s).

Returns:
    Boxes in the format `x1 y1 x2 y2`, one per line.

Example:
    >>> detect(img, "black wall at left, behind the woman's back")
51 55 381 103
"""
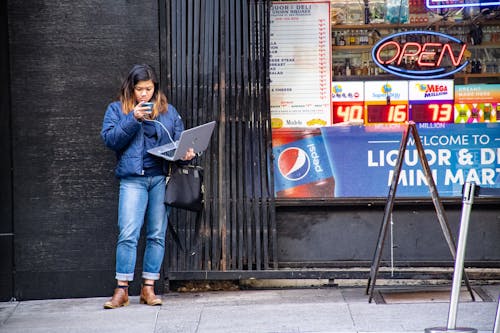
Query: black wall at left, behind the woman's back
5 0 159 299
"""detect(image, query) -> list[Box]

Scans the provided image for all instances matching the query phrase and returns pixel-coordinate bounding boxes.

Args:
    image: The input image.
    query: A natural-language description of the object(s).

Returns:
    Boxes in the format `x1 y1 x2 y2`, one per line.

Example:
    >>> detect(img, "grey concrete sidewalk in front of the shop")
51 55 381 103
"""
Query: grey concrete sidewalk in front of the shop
0 285 500 333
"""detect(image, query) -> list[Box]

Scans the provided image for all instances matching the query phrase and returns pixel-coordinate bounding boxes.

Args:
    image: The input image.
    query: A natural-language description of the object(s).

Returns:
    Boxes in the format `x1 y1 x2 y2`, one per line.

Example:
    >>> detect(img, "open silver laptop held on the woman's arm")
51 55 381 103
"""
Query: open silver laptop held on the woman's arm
148 121 215 161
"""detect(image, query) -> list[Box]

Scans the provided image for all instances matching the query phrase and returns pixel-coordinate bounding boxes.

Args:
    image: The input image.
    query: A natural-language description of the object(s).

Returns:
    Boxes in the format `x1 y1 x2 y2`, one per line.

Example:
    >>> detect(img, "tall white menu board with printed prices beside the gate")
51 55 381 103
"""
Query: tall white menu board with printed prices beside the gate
269 1 332 128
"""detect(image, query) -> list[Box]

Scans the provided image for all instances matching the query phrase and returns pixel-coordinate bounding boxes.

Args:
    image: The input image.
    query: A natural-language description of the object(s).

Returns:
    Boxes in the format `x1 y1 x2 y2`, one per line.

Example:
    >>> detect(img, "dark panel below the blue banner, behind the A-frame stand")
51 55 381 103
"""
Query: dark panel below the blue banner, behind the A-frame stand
276 203 500 267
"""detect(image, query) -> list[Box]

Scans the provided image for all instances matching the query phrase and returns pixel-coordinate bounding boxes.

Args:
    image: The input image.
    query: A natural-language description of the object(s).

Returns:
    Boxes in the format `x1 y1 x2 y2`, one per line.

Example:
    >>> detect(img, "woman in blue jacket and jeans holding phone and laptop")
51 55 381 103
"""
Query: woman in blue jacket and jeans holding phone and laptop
101 65 195 309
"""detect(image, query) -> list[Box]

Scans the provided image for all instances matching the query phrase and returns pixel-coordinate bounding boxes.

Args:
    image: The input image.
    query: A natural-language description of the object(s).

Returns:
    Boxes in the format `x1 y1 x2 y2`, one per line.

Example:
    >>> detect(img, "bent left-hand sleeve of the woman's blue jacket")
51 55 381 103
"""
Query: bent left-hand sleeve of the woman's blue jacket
101 104 141 151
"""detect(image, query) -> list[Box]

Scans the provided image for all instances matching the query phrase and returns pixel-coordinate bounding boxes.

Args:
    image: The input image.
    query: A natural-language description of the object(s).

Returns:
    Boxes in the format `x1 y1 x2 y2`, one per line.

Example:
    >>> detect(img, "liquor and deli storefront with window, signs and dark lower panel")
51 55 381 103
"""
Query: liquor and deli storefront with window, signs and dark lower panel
270 0 500 266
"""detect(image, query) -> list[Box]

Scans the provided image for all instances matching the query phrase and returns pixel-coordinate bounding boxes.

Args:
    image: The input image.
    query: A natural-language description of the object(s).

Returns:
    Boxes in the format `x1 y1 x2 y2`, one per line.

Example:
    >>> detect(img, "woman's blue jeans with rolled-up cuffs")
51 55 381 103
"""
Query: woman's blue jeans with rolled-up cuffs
116 176 170 281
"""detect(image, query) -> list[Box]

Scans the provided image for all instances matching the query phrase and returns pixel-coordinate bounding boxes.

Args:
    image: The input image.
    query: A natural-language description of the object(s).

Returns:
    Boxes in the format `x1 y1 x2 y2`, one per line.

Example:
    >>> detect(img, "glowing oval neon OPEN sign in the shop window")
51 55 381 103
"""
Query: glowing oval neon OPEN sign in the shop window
372 31 468 79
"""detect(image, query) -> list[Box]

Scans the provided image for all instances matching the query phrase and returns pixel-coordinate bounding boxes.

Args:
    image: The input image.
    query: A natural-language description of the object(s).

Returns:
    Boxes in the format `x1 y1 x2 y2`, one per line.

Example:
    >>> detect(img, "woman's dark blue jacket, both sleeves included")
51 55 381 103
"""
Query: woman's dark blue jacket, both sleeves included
101 102 184 178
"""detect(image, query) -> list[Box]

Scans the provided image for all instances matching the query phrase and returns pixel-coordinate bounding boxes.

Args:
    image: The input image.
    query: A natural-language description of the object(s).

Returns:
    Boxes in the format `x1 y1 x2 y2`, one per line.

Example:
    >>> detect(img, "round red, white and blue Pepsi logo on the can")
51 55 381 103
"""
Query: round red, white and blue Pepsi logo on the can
278 147 311 181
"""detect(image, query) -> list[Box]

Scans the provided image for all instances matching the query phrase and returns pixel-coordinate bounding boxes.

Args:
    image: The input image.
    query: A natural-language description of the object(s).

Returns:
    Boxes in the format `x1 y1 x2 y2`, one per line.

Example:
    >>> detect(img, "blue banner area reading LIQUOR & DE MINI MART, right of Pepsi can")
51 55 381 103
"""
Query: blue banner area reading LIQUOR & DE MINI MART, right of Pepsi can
321 123 500 198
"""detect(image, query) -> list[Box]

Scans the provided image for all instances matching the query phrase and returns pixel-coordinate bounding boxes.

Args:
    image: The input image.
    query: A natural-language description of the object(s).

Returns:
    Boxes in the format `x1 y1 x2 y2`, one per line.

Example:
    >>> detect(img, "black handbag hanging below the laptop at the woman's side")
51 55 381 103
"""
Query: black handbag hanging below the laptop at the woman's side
165 163 204 212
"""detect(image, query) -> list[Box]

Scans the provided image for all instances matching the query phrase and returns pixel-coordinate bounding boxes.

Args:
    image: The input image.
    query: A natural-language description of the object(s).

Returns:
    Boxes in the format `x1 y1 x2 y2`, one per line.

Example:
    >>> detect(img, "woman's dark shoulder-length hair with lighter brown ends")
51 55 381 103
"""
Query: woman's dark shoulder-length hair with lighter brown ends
118 64 167 115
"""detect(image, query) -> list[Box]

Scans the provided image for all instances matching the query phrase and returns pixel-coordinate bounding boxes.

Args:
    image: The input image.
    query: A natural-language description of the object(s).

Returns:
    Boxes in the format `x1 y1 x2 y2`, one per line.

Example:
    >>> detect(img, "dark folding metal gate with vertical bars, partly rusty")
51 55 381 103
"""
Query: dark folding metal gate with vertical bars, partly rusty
160 0 277 280
